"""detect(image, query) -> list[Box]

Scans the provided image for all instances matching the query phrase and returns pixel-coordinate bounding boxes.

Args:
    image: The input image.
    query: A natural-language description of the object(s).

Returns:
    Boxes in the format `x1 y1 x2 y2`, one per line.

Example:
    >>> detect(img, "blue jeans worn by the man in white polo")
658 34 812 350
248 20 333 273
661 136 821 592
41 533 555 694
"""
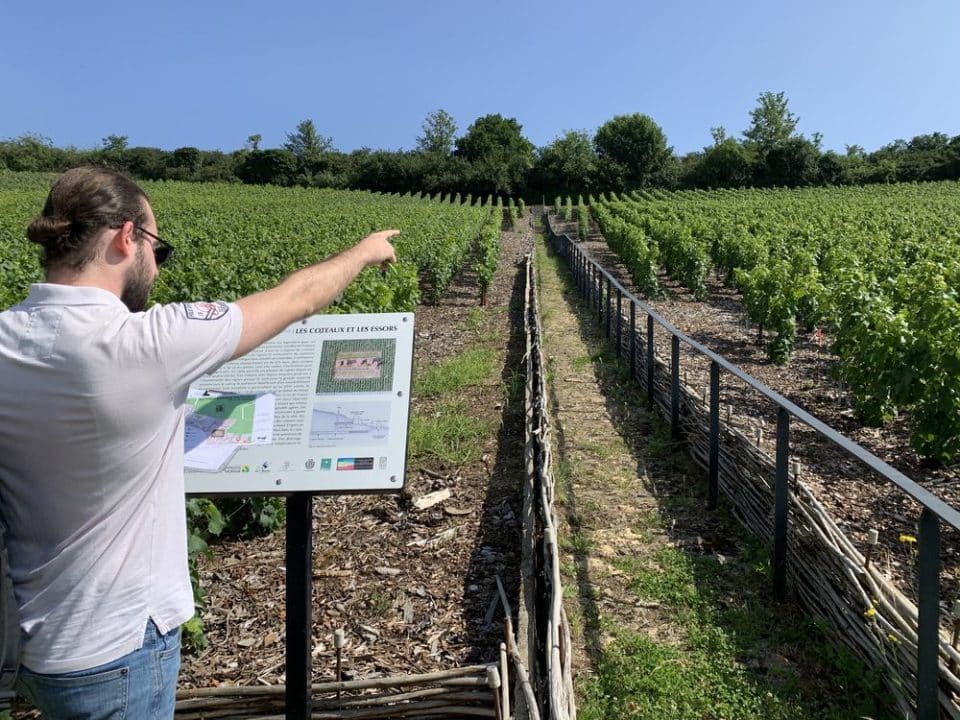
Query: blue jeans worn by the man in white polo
17 620 180 720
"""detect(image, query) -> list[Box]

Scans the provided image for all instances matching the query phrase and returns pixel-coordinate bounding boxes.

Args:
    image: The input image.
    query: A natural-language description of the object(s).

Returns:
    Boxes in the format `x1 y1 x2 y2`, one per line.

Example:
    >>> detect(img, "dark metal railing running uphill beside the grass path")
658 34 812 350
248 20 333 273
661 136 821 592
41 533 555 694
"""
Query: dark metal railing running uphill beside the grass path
545 217 960 720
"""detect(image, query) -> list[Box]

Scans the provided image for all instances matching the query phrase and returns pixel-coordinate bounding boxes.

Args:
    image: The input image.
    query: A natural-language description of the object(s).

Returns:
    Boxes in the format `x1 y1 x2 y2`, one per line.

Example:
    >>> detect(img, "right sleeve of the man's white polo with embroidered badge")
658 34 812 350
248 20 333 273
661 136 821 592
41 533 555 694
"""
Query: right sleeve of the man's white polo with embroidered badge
147 301 243 394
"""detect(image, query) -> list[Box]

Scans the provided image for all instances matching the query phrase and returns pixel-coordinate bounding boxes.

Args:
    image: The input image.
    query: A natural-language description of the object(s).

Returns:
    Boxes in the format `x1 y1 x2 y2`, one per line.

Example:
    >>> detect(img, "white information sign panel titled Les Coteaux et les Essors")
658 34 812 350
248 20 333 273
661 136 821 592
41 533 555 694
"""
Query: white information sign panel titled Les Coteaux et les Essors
184 313 414 495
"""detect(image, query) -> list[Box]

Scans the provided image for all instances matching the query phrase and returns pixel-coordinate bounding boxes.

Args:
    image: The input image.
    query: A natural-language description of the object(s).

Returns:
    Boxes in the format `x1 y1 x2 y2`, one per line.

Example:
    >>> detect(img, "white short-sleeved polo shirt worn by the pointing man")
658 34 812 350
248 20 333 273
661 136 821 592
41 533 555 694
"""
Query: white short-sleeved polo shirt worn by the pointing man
0 283 243 673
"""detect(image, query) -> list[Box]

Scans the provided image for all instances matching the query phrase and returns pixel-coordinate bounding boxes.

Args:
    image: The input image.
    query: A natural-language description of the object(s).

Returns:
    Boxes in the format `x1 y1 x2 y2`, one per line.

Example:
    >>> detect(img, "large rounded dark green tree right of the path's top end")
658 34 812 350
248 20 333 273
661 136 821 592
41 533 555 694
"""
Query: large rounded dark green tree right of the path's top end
593 113 675 192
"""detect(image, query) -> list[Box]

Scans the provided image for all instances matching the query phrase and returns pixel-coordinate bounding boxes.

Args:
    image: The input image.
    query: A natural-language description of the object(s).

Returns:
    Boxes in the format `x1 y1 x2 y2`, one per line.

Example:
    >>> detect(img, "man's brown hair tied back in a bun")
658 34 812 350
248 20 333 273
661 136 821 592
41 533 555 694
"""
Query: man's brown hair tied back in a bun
27 167 148 271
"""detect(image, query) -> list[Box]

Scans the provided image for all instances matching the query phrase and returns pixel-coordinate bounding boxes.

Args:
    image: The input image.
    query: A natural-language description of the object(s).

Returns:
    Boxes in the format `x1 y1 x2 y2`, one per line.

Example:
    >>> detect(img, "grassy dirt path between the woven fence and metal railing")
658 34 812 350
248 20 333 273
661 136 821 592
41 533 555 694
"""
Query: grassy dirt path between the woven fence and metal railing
537 232 892 720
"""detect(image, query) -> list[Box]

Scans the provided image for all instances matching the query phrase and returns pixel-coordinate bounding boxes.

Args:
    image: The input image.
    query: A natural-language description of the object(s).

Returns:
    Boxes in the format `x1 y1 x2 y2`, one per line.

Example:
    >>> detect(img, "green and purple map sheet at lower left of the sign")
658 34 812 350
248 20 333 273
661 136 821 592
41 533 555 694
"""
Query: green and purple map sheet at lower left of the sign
184 390 276 472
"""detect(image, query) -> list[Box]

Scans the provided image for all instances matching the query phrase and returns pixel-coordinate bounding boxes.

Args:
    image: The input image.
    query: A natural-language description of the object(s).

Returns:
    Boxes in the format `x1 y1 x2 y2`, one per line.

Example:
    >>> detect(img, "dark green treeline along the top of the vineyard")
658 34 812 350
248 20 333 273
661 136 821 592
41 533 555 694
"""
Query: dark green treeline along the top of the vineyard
0 92 960 200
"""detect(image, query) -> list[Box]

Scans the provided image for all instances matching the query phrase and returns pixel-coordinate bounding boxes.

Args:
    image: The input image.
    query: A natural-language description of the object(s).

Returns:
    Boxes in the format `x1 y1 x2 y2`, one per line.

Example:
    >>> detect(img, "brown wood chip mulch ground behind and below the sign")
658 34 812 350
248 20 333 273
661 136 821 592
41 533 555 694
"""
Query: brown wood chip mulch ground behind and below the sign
179 224 532 688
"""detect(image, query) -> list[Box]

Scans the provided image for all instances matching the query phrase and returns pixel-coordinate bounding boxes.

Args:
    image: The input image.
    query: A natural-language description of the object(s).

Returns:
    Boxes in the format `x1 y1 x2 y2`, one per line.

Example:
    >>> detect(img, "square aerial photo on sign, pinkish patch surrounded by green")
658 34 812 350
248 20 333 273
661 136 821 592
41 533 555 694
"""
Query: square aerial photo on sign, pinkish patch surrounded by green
317 338 396 395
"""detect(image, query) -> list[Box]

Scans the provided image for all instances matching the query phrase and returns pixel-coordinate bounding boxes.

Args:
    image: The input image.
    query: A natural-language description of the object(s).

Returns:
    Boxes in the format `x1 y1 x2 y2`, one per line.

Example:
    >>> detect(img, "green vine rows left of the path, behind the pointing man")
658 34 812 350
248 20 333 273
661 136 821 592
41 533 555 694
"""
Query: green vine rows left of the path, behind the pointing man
0 173 500 312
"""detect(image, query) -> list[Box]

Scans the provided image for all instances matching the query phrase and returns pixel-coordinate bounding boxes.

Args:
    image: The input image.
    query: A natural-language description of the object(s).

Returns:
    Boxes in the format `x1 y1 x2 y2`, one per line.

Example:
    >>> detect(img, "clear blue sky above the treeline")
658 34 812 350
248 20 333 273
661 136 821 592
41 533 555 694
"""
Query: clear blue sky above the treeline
0 0 960 154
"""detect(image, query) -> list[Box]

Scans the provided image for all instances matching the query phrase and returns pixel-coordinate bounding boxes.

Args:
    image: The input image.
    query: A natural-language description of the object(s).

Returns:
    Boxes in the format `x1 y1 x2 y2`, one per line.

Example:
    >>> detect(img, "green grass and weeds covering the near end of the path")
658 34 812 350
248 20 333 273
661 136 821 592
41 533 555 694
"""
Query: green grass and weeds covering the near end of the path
578 544 892 720
